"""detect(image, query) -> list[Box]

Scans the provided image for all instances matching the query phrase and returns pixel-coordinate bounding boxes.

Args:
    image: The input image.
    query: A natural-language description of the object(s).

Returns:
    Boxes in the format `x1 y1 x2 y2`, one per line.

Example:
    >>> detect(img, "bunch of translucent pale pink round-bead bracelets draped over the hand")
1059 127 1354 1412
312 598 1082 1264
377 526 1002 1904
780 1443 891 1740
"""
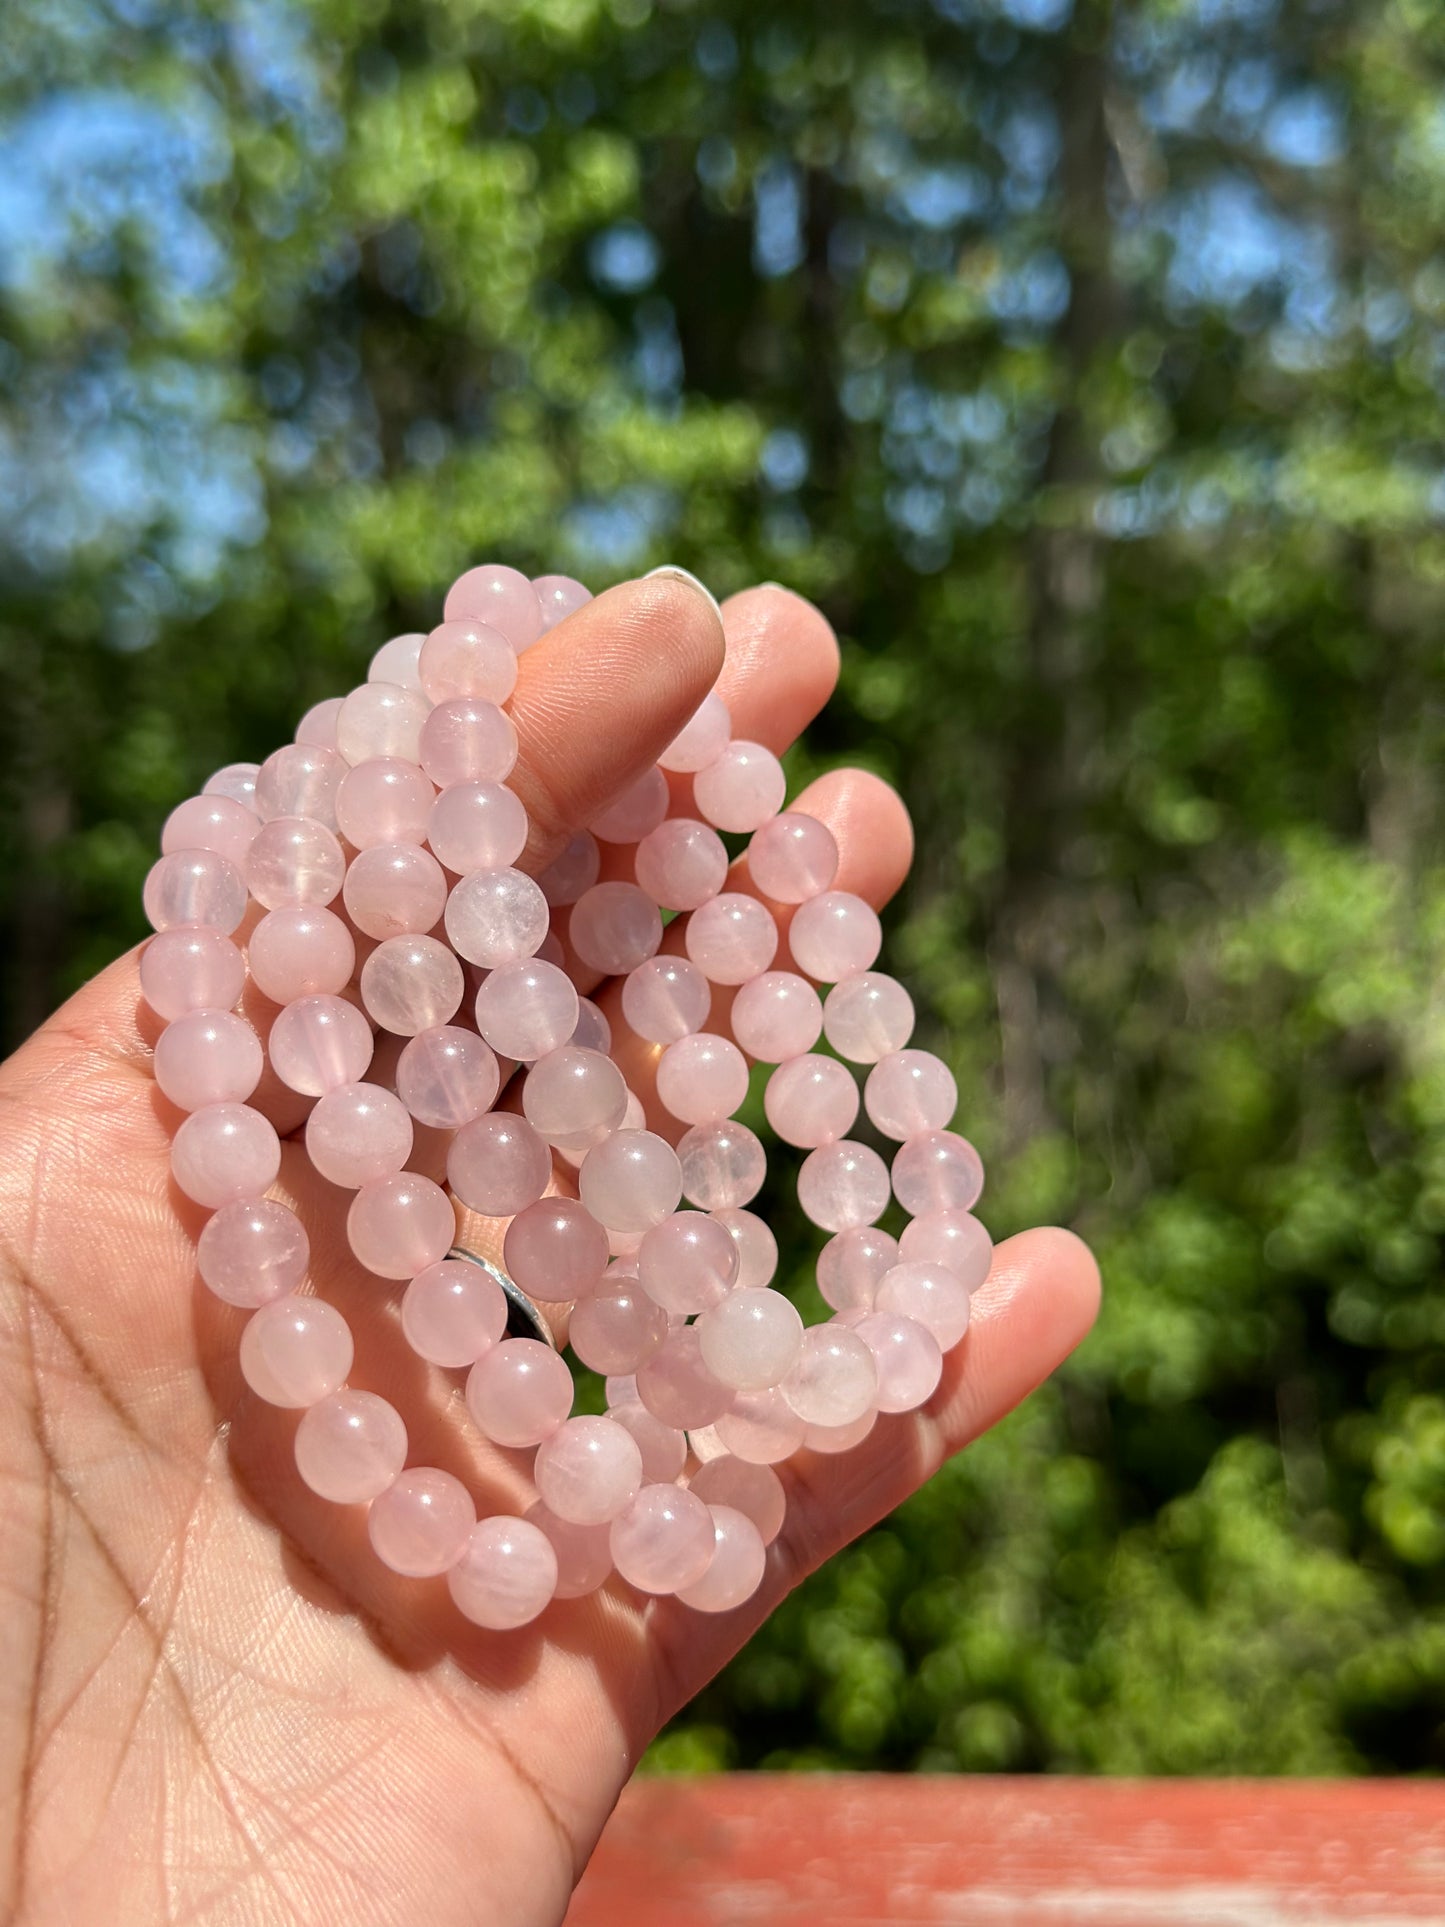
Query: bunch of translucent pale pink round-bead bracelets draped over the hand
141 565 992 1628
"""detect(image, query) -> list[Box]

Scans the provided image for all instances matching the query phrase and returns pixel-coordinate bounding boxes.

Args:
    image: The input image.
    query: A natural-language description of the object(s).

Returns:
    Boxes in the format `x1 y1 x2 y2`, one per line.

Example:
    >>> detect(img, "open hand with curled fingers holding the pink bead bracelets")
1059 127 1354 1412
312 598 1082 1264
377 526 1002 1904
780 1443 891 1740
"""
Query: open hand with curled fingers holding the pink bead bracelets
0 576 1098 1927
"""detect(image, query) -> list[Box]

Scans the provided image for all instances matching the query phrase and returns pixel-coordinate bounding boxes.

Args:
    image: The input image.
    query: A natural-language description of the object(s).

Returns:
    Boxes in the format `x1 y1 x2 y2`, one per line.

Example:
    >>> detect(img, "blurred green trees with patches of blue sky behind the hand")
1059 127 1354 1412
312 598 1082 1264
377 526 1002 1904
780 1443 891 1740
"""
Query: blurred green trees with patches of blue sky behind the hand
0 0 1445 1773
